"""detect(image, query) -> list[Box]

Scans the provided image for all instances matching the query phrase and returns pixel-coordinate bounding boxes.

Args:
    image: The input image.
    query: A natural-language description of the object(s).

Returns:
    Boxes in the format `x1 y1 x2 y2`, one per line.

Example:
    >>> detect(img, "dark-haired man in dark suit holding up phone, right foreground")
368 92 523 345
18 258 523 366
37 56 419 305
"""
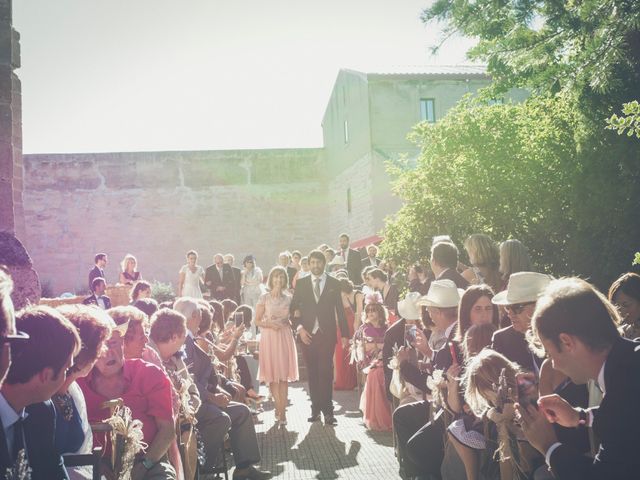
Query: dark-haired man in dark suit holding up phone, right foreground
516 278 640 480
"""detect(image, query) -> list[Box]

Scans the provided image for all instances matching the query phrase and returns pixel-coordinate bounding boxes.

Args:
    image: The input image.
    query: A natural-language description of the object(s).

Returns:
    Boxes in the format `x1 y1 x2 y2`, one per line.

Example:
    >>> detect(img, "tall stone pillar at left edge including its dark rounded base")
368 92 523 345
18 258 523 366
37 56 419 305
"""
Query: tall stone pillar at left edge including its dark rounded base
0 0 40 309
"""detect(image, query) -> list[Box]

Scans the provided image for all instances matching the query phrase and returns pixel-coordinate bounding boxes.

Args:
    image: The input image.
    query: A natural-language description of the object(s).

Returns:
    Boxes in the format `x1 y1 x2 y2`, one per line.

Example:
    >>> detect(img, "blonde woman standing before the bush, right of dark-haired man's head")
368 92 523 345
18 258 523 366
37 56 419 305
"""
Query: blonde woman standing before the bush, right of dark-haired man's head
463 233 506 292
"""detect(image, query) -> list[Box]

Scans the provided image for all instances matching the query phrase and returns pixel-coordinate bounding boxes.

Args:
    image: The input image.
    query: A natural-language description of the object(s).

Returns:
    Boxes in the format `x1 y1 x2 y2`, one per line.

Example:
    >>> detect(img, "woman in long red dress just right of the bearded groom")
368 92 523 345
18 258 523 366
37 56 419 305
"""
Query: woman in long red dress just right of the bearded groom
333 278 363 390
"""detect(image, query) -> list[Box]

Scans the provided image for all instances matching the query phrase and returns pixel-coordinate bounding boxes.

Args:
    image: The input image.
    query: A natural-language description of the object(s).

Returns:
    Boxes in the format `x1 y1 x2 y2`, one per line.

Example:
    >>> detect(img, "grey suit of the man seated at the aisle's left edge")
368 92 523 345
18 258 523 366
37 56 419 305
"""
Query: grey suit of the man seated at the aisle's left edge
185 336 260 468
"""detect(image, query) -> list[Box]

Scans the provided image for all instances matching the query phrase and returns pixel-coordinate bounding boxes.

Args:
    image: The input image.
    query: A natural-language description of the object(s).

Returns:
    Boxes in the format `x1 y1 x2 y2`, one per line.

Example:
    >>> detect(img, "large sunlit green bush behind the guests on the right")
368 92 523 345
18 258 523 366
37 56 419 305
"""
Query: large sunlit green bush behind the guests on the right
383 95 640 285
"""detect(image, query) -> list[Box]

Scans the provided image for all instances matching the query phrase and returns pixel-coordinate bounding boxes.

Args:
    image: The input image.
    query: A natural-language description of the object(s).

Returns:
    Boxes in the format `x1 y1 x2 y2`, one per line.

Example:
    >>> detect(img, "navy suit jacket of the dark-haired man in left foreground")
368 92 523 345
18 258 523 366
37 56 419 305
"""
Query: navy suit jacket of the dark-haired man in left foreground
0 400 69 480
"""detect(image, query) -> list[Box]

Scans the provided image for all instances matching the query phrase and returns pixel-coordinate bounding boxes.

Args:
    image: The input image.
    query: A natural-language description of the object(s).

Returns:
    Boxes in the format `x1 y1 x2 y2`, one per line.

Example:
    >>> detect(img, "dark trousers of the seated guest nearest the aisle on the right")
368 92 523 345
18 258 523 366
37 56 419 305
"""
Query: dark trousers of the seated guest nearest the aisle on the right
393 400 430 477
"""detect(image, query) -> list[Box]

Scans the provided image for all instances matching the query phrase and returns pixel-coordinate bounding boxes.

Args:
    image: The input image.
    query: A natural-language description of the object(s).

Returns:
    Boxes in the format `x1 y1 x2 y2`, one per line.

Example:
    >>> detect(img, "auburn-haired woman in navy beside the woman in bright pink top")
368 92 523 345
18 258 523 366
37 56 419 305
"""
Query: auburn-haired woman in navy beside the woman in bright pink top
51 305 115 468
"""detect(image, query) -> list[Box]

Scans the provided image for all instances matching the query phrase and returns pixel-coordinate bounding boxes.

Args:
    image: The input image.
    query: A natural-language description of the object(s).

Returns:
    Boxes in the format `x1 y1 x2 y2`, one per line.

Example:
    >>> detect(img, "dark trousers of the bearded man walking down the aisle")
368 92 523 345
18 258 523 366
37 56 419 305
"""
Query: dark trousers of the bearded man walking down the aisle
300 330 336 417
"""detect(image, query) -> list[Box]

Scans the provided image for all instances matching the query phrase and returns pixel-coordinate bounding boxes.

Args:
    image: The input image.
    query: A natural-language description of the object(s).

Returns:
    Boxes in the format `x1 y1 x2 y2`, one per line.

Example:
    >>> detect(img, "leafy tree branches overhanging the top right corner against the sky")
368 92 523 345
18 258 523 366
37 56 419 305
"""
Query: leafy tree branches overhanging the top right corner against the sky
422 0 640 92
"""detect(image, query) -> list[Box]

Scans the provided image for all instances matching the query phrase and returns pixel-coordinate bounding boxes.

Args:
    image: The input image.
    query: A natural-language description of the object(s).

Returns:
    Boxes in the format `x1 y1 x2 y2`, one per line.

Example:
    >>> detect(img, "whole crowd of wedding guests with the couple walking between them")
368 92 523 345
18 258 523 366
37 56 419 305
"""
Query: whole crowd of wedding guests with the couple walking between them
0 230 640 480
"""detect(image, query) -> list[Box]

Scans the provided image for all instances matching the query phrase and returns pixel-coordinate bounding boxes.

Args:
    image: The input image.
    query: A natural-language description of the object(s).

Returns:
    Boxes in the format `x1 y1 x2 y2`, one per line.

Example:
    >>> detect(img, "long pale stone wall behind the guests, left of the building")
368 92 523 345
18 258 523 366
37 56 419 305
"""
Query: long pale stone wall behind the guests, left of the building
24 149 334 294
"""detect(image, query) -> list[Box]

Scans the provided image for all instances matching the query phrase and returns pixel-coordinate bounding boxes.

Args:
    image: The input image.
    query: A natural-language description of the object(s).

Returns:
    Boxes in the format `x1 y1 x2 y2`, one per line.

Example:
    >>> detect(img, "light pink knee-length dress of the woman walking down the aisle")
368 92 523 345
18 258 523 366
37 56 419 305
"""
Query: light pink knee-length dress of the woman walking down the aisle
257 292 298 383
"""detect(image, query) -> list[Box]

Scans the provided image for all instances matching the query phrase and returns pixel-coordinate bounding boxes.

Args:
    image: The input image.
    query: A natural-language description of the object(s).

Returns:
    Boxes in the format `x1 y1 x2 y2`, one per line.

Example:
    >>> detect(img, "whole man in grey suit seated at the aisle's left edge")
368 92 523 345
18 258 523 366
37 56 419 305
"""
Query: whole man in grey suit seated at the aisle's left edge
174 297 270 480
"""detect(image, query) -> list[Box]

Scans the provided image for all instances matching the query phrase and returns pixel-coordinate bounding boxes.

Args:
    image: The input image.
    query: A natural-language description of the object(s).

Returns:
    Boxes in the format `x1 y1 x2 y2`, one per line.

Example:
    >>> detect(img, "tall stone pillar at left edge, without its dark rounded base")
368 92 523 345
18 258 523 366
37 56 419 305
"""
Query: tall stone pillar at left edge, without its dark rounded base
0 0 25 238
